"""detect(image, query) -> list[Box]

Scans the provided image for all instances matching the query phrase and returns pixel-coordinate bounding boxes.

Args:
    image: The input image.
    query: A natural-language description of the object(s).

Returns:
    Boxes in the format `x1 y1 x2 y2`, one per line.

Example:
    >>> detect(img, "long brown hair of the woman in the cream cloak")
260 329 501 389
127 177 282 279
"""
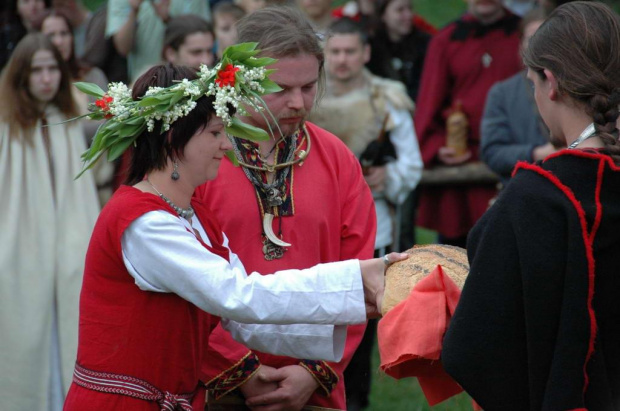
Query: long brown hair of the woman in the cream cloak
0 33 78 138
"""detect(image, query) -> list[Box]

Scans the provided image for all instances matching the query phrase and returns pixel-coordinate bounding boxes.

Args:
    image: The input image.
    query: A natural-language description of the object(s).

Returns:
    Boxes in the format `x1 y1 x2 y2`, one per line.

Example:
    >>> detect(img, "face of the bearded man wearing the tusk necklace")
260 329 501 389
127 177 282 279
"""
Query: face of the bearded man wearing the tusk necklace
248 54 319 137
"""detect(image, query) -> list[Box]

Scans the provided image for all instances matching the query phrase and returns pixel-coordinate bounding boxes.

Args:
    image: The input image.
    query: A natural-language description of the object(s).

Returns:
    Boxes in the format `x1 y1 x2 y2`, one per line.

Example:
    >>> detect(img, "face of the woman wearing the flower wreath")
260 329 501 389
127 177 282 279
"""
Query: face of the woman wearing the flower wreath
179 116 232 185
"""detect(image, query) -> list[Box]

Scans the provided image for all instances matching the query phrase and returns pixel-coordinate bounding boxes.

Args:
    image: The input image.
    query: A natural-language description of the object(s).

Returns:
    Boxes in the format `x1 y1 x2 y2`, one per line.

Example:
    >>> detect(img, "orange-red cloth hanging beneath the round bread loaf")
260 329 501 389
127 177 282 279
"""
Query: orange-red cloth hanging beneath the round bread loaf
377 265 463 406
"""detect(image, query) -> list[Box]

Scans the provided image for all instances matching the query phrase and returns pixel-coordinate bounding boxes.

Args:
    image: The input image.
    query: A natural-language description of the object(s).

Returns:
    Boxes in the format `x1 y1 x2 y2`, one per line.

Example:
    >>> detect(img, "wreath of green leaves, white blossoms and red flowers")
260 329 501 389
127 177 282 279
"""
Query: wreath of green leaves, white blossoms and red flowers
75 43 281 177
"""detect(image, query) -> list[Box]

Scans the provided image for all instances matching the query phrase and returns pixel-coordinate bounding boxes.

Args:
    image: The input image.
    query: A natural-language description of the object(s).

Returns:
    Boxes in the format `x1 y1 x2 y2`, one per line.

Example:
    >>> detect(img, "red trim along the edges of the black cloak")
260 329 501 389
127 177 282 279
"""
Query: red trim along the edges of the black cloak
513 159 596 393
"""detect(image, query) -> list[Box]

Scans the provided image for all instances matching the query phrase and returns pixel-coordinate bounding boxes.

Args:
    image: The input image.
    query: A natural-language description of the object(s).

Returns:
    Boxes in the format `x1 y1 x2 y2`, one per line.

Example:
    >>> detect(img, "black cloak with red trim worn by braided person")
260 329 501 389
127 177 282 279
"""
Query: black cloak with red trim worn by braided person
442 150 620 411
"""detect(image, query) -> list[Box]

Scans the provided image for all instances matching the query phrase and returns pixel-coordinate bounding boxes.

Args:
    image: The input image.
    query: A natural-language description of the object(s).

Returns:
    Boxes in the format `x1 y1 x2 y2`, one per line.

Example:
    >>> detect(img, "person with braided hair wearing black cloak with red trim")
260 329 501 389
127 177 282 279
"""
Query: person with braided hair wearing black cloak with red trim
441 1 620 411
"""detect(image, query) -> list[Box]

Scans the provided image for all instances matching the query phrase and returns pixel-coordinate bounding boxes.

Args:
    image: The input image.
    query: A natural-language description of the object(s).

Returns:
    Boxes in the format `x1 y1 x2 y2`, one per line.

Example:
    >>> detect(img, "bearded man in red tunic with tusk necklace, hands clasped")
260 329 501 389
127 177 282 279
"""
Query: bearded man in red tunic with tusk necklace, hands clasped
196 8 376 410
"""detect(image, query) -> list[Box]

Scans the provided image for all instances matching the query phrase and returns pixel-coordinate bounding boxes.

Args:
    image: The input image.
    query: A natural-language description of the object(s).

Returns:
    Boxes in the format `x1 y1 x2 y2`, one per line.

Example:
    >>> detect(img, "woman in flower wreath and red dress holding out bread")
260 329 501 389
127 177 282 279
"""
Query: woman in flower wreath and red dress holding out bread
65 44 401 411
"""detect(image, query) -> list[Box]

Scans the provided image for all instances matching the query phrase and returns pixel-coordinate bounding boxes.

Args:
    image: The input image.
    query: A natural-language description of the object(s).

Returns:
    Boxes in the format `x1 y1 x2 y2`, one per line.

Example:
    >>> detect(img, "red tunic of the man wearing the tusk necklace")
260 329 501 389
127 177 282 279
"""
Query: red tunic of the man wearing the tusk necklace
196 123 376 409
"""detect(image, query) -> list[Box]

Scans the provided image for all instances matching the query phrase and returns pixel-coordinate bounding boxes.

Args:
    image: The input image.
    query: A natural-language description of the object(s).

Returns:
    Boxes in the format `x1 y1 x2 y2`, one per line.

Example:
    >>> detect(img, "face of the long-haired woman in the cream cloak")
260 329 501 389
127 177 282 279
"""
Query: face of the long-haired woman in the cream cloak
28 50 61 105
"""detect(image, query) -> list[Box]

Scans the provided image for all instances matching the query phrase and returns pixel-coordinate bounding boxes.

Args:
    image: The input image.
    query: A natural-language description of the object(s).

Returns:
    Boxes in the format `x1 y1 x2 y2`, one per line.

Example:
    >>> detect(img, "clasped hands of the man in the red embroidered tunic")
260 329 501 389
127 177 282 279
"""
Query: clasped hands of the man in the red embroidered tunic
246 365 319 411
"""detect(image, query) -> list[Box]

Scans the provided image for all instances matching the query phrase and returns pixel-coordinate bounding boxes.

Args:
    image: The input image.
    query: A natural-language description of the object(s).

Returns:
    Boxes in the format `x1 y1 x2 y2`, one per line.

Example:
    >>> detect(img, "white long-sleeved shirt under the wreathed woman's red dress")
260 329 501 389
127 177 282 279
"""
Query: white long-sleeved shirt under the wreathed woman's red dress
121 211 366 361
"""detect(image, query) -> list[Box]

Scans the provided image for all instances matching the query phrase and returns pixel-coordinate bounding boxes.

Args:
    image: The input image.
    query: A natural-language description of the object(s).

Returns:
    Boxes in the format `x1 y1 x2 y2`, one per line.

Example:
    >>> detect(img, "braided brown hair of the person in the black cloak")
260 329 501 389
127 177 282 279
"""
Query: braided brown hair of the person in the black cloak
523 1 620 164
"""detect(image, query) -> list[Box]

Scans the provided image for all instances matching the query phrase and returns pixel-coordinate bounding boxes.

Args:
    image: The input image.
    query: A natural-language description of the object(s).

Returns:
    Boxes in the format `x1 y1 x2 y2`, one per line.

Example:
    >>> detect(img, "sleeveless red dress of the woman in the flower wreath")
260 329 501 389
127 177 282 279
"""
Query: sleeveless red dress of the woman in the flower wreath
65 186 228 411
